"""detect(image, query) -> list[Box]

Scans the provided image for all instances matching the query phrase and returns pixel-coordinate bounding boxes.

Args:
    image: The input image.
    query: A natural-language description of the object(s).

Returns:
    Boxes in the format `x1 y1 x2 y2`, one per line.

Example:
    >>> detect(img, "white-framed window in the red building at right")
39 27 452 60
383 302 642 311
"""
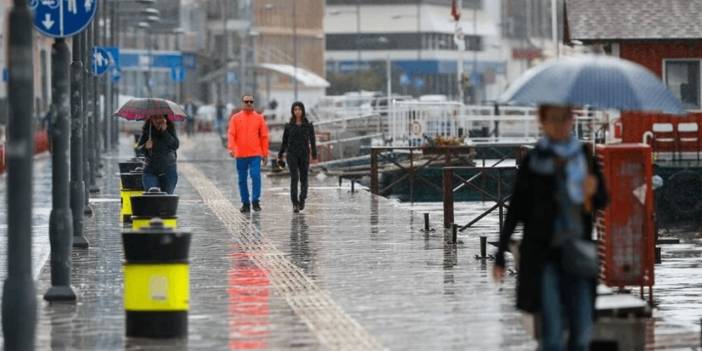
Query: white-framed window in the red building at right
665 60 700 109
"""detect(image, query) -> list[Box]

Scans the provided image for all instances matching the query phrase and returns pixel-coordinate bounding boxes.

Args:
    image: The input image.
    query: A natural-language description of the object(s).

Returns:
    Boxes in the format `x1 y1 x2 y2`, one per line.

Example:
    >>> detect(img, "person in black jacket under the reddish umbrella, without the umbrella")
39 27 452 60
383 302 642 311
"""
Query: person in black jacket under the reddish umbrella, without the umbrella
136 116 180 194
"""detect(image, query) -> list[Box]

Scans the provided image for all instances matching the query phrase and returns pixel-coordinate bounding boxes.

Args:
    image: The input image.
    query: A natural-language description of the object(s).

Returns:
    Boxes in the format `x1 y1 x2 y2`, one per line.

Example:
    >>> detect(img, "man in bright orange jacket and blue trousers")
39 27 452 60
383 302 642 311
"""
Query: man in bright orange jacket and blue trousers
228 95 268 213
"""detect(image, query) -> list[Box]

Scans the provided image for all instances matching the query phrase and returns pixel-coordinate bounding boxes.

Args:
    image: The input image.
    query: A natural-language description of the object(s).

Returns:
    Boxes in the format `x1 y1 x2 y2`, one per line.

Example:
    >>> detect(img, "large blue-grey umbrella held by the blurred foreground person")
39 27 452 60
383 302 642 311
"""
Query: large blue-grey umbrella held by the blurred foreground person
499 55 686 115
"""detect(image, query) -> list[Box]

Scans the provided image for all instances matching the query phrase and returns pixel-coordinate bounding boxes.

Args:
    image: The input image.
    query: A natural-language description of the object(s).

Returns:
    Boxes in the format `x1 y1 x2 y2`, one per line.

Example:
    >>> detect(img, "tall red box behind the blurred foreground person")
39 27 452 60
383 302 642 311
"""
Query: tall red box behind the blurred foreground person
596 144 655 296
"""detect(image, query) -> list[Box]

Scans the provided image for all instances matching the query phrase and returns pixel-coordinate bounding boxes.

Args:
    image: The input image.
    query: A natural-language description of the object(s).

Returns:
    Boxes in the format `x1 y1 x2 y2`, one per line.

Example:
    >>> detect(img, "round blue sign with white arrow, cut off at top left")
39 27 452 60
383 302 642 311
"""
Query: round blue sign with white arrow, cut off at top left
28 0 97 38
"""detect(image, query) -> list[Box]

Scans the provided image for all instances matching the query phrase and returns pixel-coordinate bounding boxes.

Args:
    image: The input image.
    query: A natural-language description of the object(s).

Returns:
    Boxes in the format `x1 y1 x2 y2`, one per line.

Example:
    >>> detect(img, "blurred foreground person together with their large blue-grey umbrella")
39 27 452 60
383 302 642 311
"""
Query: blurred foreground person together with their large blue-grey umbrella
493 55 685 351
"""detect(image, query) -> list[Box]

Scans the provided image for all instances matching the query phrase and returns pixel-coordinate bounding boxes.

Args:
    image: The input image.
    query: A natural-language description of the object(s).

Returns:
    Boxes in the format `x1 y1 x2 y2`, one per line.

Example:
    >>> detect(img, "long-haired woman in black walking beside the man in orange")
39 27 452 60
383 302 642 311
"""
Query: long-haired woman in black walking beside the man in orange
278 101 317 213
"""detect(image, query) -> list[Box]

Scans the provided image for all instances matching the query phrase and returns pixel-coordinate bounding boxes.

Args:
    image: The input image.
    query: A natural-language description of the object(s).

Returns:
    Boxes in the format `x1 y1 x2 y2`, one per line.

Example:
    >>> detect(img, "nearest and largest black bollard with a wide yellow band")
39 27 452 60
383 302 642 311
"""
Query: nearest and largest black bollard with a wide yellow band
122 218 191 338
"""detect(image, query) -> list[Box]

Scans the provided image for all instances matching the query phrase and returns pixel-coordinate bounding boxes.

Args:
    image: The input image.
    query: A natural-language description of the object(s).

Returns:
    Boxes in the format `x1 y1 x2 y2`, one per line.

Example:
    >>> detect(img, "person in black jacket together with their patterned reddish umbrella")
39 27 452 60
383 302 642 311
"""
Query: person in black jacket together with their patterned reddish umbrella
115 98 186 194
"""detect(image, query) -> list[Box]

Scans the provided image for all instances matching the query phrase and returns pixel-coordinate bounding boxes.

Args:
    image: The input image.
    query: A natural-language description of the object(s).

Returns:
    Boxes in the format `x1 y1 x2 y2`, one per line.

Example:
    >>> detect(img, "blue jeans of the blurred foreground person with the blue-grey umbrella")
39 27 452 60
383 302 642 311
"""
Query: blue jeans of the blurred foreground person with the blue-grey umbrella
541 262 593 351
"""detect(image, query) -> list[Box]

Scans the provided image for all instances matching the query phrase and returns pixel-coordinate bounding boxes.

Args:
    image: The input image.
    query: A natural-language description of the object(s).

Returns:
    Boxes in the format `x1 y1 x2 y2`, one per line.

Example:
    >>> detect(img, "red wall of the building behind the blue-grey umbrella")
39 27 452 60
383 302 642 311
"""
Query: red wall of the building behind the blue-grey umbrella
618 40 702 150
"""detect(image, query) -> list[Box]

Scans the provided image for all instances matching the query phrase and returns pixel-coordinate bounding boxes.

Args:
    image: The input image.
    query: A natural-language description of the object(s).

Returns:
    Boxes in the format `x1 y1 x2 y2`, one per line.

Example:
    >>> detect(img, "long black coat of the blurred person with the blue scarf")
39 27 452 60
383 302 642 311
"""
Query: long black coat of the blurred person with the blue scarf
495 145 608 312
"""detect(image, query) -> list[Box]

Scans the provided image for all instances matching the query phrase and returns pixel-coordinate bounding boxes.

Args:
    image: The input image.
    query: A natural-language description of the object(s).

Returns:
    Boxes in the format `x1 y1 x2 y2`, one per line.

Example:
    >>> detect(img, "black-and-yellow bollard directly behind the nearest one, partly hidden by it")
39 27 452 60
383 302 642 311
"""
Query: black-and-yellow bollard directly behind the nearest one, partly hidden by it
131 188 178 230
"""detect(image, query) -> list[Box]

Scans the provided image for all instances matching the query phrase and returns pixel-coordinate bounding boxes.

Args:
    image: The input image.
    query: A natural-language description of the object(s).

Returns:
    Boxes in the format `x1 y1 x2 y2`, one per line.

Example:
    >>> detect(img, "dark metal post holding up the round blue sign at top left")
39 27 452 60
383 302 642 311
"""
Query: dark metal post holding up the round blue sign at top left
44 38 76 302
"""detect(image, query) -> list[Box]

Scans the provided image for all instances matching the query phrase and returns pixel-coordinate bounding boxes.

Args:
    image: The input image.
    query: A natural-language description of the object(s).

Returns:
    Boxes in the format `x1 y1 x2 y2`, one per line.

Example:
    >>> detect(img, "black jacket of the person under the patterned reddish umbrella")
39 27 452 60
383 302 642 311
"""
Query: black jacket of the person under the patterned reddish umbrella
137 122 180 175
